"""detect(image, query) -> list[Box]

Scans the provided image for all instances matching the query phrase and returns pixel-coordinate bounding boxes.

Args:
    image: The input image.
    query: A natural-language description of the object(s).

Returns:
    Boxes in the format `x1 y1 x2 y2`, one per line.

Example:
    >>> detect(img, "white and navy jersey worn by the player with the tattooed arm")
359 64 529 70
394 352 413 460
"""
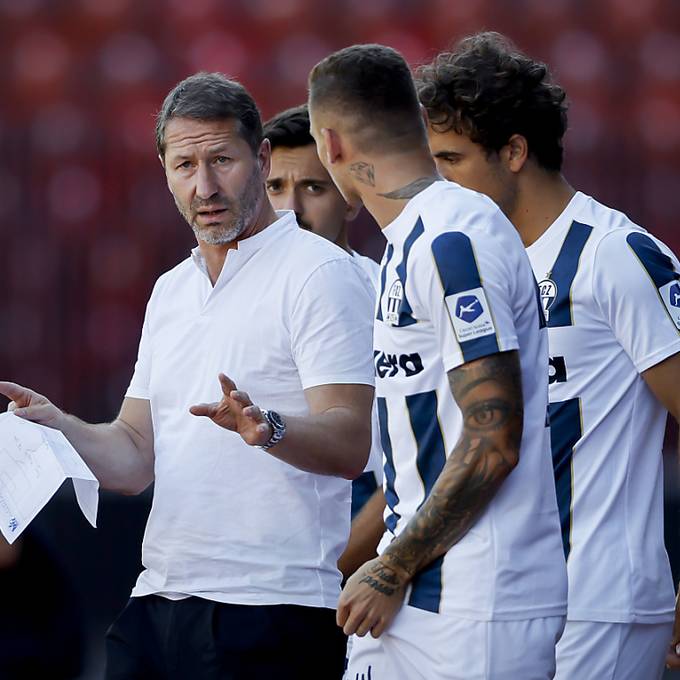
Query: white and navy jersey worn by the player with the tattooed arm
374 181 566 621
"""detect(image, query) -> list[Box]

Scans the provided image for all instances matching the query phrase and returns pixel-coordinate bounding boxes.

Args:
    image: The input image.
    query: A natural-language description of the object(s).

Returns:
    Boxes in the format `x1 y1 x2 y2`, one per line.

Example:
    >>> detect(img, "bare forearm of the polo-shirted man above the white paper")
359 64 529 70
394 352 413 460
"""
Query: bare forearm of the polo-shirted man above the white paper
57 413 154 494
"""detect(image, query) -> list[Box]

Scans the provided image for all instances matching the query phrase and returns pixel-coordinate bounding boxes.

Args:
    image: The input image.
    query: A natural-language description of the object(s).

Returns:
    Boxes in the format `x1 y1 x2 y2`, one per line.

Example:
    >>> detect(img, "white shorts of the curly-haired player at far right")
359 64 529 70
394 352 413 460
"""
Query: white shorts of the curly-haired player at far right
555 621 673 680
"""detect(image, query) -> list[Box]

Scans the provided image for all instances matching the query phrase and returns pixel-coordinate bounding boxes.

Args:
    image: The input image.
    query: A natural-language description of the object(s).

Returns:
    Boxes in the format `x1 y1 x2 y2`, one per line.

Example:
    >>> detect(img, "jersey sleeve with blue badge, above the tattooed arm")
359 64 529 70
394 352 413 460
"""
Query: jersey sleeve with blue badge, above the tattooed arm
423 231 518 371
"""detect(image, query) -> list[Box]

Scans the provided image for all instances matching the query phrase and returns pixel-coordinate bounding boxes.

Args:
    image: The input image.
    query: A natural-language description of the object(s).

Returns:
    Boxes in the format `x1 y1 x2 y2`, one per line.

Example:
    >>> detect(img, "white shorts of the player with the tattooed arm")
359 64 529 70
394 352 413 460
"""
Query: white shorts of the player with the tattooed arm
346 606 564 680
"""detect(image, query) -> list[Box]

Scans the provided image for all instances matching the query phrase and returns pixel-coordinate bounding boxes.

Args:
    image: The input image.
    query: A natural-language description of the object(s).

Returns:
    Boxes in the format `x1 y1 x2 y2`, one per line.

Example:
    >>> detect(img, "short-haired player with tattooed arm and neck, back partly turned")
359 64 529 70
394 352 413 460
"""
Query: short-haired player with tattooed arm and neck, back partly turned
309 45 566 680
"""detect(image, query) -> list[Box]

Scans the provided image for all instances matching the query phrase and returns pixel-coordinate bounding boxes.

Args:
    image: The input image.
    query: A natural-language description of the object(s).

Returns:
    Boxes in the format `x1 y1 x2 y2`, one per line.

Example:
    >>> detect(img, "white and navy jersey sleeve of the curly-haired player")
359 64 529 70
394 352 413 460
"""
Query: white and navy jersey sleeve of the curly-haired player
592 231 680 373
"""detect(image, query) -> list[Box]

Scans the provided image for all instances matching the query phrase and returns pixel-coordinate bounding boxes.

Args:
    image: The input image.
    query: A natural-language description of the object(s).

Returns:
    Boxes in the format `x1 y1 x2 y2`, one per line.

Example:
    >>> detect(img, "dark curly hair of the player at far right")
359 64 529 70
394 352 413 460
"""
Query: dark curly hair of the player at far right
416 32 567 171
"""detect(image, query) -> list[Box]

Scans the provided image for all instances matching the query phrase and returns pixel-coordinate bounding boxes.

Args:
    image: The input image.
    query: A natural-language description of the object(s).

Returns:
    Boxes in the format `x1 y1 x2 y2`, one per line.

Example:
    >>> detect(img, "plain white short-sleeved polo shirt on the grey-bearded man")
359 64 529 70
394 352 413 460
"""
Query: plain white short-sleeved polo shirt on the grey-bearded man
126 212 373 607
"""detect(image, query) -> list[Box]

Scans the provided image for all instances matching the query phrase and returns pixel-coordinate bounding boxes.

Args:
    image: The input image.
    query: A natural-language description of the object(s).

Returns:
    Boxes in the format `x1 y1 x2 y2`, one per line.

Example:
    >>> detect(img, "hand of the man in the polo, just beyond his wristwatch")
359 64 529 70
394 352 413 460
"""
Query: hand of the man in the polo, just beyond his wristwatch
189 373 272 446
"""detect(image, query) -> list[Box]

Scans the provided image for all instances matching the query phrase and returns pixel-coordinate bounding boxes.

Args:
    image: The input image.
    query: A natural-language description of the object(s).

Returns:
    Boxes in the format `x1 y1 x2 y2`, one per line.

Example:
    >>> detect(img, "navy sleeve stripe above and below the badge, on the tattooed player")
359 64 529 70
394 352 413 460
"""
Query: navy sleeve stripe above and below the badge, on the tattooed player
431 231 500 361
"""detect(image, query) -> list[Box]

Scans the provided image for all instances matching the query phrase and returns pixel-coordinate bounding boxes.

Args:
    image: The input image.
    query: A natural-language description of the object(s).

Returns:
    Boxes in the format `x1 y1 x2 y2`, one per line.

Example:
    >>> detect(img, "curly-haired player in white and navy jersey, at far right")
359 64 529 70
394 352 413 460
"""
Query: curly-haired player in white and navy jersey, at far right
419 33 680 680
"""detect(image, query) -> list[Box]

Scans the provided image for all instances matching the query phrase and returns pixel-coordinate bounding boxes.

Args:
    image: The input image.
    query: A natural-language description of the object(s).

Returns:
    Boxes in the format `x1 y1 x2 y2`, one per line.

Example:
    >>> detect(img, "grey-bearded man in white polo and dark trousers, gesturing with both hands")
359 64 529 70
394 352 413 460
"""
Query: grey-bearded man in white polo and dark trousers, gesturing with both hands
0 73 373 680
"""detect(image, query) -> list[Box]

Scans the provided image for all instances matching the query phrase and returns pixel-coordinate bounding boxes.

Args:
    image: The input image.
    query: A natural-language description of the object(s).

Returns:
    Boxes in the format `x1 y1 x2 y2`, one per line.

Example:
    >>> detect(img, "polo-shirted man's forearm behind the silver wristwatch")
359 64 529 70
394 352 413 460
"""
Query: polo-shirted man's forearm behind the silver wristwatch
269 406 371 479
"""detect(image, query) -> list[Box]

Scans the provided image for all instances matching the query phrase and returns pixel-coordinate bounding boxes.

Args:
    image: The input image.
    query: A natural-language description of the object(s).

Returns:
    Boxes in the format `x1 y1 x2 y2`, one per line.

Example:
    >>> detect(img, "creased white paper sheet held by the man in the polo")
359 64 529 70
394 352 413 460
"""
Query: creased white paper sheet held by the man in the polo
0 413 99 543
